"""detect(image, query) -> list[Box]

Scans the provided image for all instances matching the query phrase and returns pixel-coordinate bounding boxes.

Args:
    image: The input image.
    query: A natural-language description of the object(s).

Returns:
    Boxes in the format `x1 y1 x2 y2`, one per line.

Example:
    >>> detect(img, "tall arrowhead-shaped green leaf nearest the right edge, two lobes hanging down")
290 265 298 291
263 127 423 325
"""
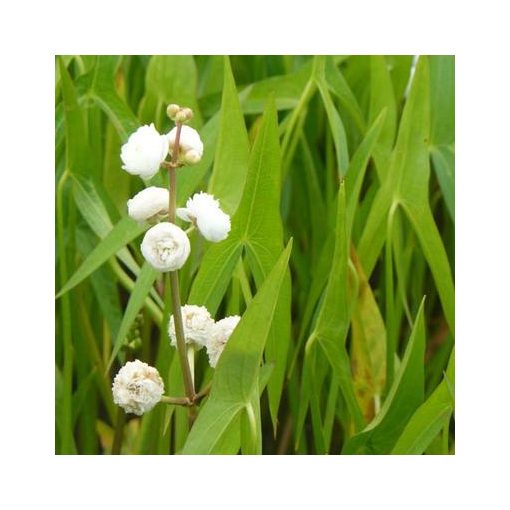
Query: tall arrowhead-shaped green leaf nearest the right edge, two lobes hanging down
358 57 455 332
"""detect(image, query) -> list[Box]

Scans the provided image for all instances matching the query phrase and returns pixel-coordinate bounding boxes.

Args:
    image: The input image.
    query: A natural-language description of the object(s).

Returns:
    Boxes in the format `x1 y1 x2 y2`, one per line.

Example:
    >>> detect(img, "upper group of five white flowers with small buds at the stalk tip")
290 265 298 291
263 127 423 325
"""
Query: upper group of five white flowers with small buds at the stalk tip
120 105 230 272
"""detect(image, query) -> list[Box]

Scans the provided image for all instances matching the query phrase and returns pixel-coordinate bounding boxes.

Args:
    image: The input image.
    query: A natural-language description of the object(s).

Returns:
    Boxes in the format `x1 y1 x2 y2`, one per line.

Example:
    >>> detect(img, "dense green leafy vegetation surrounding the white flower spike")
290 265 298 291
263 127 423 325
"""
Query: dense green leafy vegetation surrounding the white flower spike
55 56 455 454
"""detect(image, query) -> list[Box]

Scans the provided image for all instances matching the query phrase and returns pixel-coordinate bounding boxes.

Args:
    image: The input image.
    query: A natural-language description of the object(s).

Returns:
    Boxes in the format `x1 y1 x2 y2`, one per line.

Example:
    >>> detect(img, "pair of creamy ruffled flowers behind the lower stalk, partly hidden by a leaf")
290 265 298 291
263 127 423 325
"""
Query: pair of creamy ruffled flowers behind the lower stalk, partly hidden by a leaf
168 305 241 368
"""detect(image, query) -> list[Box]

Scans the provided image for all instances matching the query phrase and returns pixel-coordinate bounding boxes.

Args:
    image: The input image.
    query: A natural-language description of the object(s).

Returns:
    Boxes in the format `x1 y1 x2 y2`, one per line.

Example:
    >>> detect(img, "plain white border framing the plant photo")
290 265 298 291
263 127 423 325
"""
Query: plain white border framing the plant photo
1 0 510 509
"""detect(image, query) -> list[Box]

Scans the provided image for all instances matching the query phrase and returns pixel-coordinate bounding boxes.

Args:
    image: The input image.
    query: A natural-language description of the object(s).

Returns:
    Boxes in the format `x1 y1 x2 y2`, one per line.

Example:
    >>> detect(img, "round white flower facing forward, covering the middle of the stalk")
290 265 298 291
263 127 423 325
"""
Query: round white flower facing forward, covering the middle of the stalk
141 222 190 272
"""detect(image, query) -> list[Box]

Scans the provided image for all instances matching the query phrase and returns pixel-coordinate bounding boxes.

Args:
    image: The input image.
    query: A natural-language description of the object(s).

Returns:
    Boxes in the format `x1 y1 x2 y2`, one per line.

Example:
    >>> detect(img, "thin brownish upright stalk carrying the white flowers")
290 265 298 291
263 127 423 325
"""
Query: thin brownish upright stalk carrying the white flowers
165 122 195 402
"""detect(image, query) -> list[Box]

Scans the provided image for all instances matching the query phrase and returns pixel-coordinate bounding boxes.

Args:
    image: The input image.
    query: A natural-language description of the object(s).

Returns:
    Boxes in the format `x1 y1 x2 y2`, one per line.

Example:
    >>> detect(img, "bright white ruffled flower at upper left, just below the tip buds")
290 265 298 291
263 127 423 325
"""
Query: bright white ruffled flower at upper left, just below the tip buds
120 124 168 179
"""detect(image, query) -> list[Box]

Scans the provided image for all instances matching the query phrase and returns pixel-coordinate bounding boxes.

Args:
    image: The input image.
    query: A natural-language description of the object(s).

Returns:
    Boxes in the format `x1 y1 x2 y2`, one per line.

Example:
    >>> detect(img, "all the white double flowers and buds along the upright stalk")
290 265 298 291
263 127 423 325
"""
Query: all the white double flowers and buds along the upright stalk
112 104 240 415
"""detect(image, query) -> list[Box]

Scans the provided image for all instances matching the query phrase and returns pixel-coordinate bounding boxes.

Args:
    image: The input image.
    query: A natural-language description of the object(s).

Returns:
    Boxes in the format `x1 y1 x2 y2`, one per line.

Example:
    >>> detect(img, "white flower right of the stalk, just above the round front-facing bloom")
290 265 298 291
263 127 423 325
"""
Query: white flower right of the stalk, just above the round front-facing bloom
177 192 230 243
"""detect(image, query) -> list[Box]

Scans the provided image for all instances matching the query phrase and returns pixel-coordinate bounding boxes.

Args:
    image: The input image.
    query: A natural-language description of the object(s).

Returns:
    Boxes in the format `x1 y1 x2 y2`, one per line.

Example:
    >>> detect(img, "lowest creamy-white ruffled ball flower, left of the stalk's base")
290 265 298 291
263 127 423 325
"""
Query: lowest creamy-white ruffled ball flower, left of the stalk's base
112 360 164 416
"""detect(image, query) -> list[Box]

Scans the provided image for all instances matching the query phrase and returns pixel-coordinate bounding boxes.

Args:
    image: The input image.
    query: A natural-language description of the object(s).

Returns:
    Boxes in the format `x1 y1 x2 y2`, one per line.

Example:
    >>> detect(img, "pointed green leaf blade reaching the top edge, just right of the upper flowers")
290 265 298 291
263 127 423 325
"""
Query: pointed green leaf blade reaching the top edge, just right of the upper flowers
205 57 250 214
